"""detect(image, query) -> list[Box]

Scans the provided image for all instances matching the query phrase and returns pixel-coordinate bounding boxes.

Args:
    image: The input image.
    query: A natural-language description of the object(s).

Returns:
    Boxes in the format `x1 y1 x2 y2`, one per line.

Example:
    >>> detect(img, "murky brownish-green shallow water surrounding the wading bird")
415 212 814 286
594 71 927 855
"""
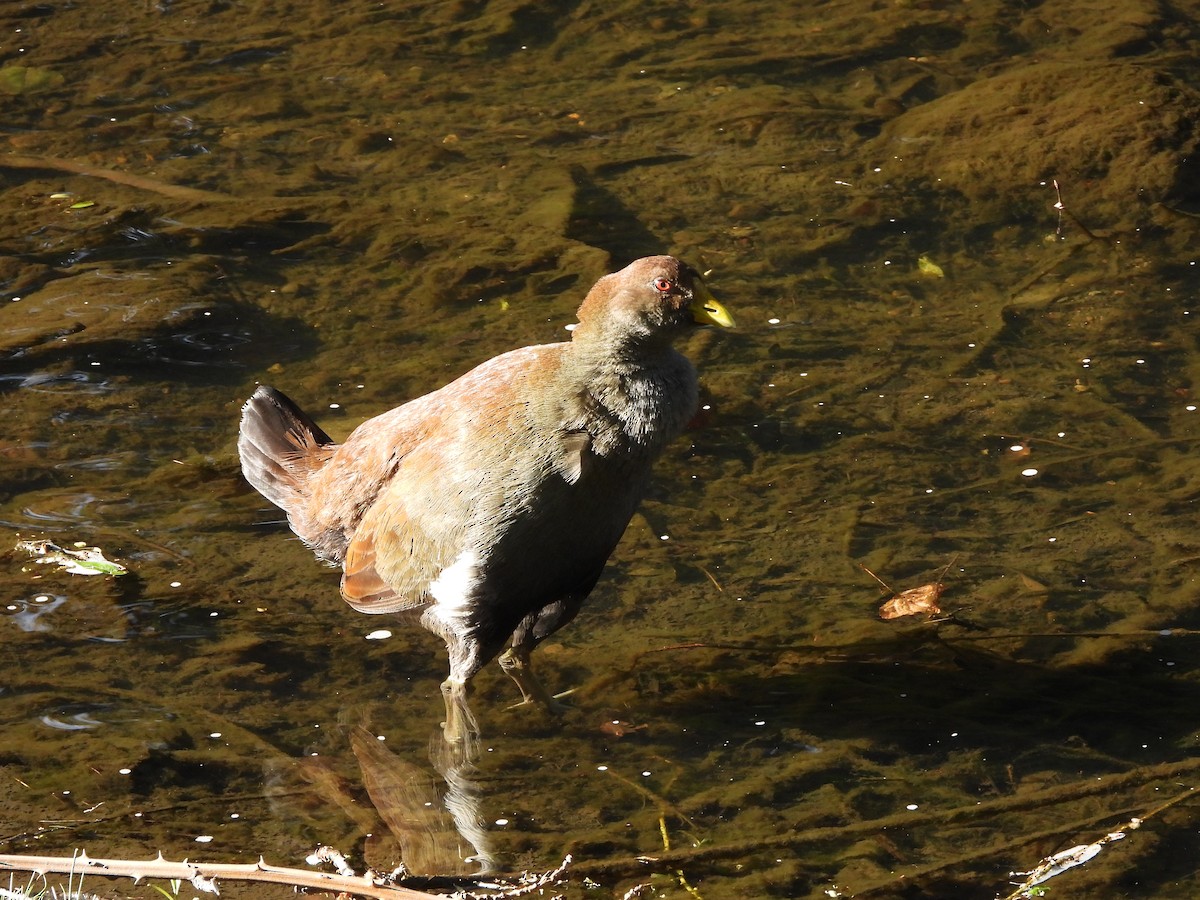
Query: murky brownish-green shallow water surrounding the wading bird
0 0 1200 900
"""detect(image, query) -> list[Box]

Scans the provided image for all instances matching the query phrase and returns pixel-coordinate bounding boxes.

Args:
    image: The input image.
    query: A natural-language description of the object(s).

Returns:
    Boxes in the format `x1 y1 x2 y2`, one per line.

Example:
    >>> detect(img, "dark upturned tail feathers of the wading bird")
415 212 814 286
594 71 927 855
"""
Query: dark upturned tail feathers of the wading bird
238 384 334 514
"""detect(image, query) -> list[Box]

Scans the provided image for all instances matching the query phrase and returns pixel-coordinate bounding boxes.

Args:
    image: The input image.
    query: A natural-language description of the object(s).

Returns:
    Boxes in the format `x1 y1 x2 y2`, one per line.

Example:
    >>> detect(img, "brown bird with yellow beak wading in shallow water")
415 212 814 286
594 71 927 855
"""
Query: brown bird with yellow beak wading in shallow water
238 257 732 742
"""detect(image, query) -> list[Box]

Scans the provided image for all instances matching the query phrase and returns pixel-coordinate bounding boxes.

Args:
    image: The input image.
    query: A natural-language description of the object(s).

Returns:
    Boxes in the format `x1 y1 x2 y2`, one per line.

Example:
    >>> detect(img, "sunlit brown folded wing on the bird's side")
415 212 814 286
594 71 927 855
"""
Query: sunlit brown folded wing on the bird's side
326 344 576 613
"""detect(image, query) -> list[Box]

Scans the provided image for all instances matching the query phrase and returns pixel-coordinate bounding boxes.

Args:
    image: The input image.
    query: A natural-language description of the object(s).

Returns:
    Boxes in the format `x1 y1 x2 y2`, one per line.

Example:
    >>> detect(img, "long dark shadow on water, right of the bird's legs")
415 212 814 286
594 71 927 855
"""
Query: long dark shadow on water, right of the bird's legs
660 635 1195 763
